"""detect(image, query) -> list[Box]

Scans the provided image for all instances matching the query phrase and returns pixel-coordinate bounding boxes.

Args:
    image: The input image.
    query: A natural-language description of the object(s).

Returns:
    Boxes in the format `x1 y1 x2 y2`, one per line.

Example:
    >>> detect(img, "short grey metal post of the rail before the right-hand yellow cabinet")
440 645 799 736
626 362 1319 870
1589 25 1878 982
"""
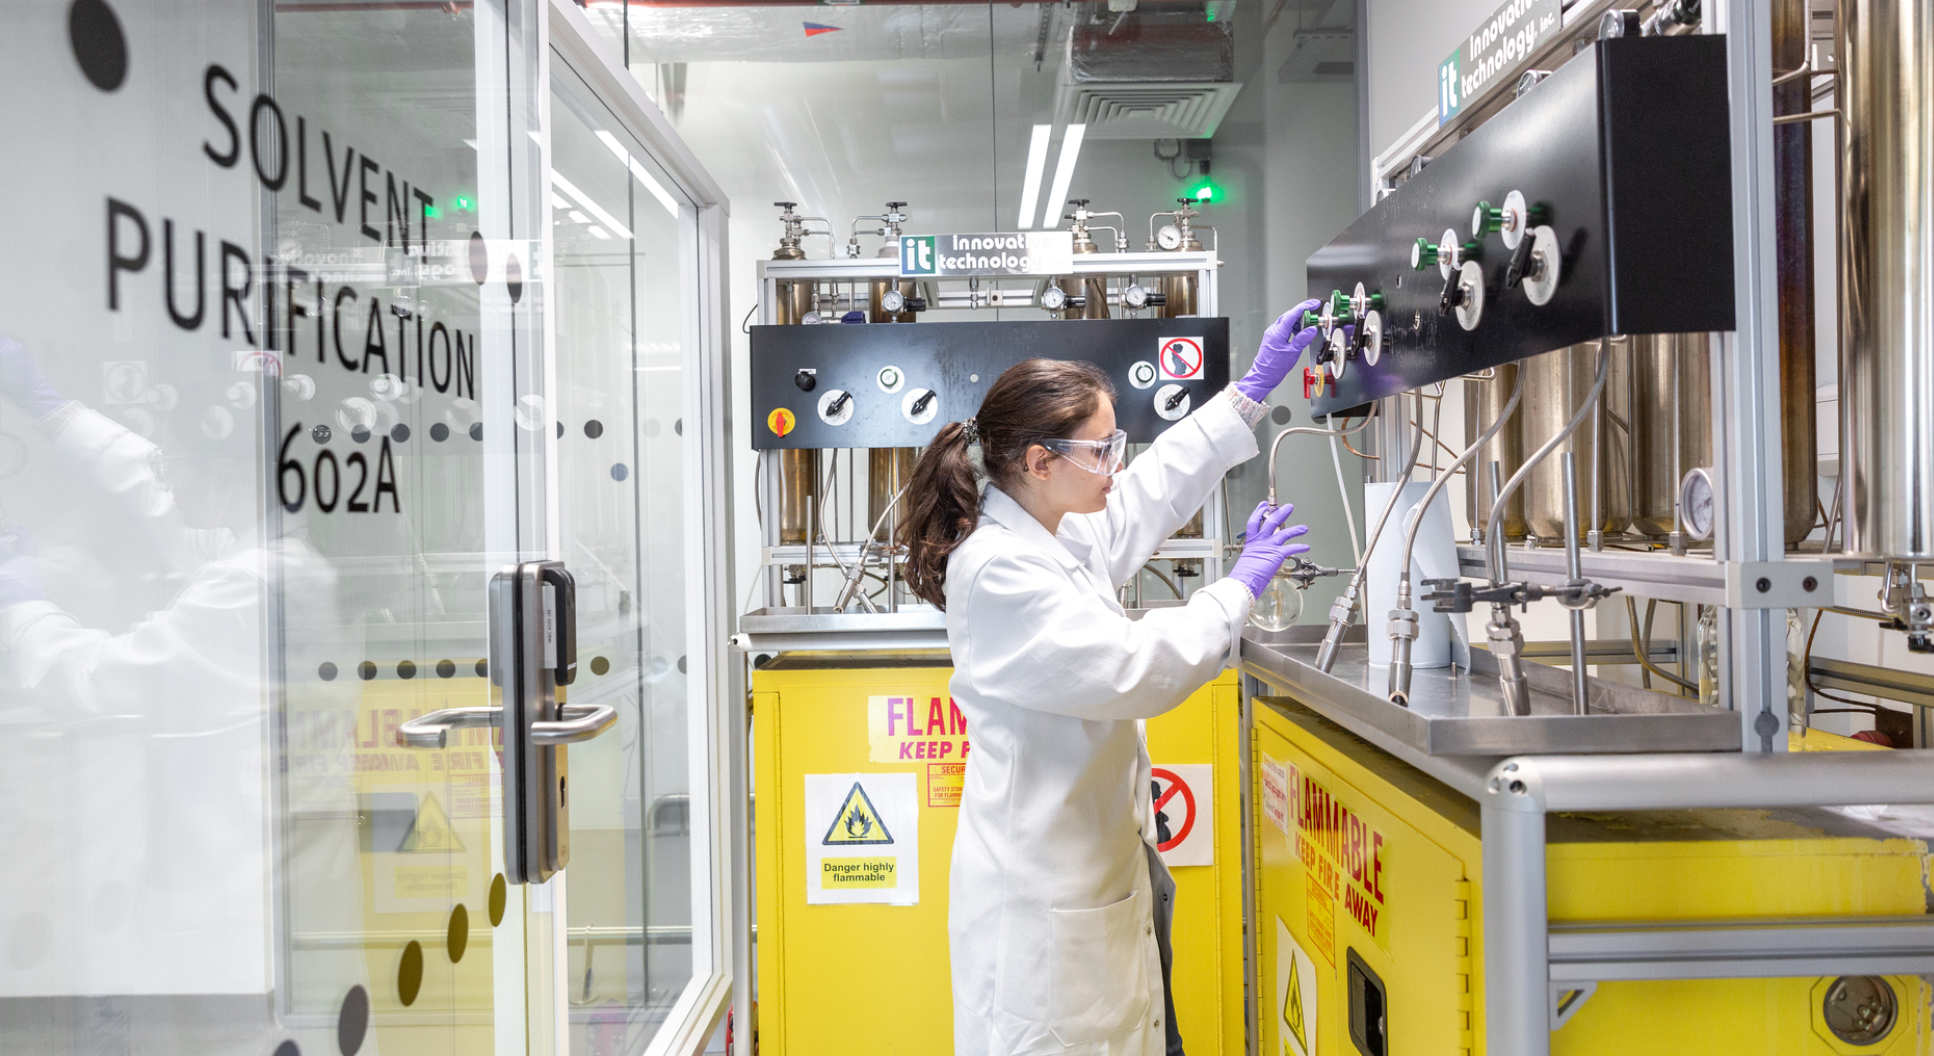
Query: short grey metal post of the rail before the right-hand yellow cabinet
1480 760 1551 1056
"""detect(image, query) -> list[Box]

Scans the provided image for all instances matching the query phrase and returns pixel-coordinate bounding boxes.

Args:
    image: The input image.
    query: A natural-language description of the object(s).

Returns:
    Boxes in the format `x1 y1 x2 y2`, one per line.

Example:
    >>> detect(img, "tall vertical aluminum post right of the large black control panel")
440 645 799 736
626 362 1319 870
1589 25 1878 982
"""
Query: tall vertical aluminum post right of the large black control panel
1710 0 1787 752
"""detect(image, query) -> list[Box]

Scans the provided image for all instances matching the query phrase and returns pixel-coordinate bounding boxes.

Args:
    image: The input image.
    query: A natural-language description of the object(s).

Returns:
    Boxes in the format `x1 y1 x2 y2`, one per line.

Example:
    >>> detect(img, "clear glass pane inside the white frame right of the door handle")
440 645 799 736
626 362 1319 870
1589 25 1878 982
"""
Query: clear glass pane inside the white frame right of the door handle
551 56 710 1054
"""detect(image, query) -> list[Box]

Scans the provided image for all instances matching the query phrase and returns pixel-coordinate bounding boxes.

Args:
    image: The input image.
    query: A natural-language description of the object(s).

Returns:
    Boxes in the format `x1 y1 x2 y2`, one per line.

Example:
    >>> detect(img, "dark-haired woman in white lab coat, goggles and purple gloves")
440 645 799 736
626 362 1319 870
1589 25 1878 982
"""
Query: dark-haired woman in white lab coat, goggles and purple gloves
899 302 1315 1056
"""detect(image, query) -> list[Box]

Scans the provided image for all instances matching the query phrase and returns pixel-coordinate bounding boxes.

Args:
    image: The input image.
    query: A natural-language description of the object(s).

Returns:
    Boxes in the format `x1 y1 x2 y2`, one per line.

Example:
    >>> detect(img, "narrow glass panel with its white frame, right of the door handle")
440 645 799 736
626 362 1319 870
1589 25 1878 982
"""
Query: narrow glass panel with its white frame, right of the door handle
547 22 727 1056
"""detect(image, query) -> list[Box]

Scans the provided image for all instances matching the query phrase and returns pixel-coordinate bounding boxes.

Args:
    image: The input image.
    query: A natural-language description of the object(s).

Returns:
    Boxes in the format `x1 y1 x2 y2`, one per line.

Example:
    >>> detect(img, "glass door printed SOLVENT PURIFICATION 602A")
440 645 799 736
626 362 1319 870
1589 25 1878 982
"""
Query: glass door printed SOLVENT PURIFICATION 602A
0 0 560 1056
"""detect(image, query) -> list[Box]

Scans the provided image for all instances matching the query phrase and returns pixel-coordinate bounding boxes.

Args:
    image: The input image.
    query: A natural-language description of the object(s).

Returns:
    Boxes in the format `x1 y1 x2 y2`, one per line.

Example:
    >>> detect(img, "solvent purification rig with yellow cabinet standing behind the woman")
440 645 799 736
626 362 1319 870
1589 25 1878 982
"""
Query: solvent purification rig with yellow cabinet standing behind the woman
739 199 1244 1054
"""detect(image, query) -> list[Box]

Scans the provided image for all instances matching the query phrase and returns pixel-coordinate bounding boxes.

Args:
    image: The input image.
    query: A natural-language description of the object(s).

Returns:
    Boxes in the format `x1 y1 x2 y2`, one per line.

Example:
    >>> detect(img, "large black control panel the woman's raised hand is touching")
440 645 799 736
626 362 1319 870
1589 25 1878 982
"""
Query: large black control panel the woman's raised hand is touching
1309 35 1733 414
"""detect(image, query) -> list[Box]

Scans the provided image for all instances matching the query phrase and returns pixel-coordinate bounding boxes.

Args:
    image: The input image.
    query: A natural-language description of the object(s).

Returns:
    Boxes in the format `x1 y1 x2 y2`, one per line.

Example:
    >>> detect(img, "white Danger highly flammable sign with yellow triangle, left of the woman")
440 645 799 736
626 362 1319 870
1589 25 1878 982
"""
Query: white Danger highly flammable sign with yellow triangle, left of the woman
803 774 921 905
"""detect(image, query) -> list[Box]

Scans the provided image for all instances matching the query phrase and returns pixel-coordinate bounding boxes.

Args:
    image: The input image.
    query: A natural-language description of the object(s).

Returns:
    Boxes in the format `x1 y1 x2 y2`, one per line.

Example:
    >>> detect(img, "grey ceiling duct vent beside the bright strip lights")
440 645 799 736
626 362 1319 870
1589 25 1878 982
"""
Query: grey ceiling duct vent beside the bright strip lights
1054 12 1242 139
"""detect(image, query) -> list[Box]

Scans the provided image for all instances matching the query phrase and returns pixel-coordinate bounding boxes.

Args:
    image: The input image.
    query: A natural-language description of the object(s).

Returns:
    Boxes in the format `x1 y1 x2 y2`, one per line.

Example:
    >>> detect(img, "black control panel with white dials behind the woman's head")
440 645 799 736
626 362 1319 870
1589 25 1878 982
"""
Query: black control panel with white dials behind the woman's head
750 317 1228 451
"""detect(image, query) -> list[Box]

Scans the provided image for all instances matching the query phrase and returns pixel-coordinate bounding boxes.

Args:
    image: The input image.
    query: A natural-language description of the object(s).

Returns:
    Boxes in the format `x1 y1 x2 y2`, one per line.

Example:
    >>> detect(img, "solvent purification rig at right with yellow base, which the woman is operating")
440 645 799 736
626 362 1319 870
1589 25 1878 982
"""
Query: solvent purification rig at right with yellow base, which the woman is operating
1242 0 1934 1056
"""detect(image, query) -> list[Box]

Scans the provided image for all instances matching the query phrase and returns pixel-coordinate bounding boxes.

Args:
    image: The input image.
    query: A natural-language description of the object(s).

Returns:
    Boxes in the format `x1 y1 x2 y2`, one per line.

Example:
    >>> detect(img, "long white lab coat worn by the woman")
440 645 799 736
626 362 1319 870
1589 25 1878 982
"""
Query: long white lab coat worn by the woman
946 393 1257 1056
